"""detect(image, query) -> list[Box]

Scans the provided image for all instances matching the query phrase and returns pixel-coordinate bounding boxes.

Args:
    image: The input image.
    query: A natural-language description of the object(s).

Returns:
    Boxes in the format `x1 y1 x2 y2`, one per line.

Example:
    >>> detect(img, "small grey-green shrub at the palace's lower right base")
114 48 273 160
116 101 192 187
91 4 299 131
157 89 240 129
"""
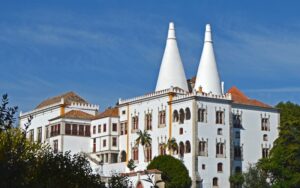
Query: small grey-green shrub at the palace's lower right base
243 165 271 188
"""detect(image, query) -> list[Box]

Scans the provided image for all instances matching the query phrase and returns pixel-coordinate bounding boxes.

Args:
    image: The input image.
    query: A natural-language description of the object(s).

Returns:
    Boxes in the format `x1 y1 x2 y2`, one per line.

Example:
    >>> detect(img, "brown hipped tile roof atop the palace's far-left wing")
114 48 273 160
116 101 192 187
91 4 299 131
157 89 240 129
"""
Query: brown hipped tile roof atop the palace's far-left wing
35 91 88 109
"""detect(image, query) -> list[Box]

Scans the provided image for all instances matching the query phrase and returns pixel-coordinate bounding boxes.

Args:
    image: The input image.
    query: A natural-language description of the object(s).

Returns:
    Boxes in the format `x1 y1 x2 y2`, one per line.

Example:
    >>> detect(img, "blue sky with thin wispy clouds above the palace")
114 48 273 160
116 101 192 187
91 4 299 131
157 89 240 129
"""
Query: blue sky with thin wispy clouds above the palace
0 0 300 111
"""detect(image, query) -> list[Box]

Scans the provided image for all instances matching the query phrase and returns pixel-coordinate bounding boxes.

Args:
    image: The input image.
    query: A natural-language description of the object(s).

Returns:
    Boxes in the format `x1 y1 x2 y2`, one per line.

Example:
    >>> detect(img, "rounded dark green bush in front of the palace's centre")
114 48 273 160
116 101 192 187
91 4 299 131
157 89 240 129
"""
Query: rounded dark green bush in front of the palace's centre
147 155 192 188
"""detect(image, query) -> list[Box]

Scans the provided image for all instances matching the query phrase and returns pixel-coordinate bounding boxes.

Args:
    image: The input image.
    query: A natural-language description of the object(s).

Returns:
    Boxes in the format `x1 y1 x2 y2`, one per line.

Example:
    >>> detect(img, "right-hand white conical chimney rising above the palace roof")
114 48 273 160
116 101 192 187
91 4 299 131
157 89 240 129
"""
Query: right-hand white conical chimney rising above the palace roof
194 24 222 95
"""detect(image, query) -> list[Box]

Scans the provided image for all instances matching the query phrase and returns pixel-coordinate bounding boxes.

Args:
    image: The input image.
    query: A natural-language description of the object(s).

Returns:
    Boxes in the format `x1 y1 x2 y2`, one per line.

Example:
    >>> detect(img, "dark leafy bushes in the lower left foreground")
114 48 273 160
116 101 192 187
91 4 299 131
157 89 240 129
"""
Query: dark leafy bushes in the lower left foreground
0 95 102 188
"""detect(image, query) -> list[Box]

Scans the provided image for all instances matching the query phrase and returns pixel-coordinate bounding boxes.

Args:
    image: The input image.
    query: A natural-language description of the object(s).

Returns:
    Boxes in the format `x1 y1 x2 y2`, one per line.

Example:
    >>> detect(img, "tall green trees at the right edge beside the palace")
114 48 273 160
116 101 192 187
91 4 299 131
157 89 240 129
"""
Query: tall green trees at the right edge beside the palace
258 102 300 188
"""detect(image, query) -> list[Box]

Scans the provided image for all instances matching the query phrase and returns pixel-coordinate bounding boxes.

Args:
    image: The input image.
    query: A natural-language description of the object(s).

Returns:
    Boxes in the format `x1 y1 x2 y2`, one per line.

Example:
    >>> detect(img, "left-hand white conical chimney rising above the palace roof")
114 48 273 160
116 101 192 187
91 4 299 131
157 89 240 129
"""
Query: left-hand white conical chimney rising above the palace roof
155 22 188 91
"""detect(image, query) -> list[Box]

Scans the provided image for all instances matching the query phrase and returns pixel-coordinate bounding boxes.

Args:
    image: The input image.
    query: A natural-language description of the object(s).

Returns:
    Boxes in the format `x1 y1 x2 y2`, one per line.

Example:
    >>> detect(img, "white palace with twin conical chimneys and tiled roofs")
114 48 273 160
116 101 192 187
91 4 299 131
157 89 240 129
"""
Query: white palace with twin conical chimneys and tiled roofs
19 23 280 188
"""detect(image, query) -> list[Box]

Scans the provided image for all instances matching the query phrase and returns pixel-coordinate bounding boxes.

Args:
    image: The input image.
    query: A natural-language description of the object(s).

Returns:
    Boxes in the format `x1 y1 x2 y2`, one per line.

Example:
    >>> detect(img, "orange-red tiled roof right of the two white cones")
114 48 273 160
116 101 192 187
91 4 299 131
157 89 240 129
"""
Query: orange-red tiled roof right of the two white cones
227 86 272 108
